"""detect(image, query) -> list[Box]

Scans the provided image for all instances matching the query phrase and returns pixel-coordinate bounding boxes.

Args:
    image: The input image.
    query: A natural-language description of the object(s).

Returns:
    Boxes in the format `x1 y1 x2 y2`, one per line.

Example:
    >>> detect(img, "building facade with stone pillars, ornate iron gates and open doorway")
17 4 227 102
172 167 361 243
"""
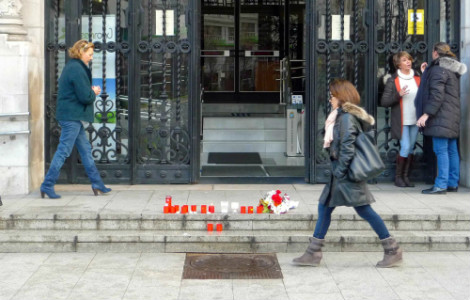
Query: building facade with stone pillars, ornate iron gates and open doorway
0 0 470 194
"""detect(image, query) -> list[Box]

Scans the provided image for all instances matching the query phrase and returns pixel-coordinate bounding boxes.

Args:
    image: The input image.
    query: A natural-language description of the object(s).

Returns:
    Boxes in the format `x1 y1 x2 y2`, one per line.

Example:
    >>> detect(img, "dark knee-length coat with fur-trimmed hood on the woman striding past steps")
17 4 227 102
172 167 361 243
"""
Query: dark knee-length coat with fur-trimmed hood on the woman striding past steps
319 103 375 207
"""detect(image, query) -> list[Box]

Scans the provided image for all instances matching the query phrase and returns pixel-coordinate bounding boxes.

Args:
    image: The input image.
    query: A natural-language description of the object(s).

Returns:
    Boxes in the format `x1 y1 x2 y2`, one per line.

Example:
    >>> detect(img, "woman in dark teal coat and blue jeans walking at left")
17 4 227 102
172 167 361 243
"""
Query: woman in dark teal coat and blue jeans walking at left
40 40 111 198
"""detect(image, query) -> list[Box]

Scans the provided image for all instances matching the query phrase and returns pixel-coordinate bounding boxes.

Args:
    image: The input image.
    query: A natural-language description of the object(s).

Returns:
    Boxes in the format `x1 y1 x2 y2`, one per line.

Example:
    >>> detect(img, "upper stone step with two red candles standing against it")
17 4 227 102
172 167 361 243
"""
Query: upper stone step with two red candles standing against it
0 213 470 232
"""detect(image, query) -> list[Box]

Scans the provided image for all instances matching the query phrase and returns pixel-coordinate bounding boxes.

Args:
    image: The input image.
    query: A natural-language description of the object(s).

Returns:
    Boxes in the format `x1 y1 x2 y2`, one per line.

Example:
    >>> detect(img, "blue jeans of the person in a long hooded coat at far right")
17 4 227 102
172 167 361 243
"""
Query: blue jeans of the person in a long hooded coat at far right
432 137 460 189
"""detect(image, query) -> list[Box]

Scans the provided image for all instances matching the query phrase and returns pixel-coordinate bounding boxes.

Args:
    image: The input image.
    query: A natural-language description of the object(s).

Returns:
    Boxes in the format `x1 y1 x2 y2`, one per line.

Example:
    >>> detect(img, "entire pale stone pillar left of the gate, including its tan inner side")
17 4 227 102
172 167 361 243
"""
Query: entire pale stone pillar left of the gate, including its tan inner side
0 0 44 195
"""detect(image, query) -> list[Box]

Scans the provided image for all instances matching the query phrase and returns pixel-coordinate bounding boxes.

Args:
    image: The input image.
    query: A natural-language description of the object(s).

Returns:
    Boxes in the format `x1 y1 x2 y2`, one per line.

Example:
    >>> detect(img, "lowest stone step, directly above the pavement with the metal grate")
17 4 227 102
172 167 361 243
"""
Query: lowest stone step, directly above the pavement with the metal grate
0 229 470 253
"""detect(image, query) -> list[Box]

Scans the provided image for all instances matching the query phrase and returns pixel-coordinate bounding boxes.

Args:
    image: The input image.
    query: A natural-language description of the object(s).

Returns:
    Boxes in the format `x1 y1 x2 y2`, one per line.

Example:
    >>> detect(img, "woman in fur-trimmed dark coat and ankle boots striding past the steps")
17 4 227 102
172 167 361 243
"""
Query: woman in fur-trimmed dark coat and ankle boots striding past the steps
292 79 402 268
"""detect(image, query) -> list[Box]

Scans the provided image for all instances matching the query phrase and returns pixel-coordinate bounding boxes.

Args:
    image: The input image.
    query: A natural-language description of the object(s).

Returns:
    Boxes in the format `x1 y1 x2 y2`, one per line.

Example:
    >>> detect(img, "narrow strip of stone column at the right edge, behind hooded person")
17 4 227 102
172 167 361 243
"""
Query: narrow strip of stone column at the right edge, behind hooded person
460 0 470 187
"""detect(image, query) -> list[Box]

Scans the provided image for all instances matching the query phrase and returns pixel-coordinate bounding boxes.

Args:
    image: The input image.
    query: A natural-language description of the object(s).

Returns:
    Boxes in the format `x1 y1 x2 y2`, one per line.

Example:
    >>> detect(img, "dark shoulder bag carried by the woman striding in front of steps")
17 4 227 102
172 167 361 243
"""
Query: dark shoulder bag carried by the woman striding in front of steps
348 126 385 182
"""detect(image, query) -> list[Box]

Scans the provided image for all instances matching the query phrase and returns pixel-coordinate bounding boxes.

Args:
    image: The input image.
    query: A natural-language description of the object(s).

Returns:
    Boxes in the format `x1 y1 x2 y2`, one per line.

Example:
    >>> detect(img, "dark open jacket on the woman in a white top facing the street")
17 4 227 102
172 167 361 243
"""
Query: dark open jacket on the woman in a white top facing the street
380 72 420 140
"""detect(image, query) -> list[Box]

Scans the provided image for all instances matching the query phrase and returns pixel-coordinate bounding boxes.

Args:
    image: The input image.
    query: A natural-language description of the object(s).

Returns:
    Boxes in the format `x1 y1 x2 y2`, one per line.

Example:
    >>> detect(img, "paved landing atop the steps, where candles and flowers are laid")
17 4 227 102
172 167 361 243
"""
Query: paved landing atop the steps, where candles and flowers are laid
0 183 470 216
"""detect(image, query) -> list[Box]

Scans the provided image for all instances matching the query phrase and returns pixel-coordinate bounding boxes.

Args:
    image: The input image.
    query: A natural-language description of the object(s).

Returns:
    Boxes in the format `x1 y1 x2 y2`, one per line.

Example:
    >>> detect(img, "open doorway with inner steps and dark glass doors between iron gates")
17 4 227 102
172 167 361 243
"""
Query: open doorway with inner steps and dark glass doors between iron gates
200 0 306 179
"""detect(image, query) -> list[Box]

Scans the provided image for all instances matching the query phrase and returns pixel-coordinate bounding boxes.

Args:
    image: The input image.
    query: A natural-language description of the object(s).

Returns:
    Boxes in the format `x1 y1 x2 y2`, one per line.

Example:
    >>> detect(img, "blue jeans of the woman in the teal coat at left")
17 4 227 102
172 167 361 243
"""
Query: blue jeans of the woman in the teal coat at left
41 121 103 189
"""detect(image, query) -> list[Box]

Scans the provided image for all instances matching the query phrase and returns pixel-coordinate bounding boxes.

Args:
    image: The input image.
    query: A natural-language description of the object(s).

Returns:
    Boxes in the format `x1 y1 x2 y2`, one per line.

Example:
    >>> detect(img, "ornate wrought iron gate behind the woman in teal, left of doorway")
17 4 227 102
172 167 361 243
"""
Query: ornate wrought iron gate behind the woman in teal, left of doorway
46 0 198 183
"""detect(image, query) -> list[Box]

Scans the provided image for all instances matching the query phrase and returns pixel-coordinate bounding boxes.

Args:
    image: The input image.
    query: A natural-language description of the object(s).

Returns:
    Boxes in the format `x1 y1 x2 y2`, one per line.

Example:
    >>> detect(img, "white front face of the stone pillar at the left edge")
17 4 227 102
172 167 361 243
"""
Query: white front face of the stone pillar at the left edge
0 0 30 195
